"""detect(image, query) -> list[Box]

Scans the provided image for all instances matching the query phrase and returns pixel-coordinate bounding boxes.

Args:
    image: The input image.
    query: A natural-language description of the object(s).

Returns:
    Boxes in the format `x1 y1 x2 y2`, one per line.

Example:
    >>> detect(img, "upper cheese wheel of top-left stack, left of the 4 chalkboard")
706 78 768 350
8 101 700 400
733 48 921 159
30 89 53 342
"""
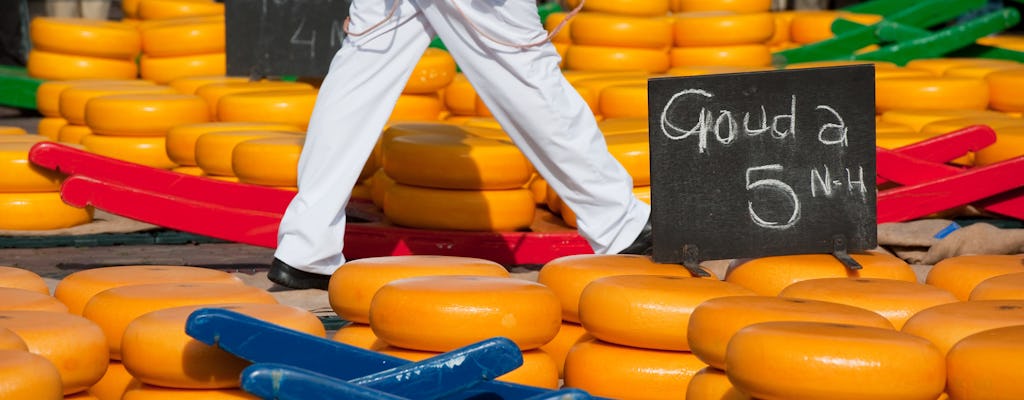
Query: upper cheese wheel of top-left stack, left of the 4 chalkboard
29 16 142 60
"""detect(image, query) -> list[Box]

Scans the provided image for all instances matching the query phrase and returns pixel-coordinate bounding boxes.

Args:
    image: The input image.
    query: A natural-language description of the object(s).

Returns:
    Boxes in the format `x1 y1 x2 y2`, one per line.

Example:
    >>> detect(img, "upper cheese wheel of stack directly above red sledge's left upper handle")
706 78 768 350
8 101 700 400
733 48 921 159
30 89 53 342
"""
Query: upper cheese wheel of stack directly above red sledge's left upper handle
85 94 210 136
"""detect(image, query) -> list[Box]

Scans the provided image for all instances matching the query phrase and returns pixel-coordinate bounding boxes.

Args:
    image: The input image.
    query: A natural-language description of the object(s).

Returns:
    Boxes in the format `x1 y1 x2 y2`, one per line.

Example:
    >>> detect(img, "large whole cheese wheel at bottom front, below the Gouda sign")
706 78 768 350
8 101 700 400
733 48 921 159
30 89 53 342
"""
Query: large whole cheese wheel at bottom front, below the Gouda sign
725 321 946 400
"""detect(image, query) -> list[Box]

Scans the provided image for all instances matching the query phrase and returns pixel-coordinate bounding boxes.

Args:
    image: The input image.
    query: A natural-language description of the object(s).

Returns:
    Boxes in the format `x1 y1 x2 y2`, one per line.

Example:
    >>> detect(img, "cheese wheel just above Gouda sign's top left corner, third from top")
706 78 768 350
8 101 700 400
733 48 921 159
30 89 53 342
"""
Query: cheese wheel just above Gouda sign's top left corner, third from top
565 45 670 73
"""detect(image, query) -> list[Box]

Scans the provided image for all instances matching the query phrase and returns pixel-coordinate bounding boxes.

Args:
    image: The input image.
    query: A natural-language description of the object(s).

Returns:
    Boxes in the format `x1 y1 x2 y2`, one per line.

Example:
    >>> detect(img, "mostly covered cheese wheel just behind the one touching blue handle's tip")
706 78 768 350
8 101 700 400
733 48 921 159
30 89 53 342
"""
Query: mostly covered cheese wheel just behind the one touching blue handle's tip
82 282 278 360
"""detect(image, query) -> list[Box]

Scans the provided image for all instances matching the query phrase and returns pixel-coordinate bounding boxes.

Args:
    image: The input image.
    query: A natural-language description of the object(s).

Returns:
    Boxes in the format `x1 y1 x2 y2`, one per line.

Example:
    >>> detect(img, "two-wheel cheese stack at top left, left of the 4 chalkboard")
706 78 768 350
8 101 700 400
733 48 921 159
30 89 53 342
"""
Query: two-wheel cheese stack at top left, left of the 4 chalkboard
28 17 141 80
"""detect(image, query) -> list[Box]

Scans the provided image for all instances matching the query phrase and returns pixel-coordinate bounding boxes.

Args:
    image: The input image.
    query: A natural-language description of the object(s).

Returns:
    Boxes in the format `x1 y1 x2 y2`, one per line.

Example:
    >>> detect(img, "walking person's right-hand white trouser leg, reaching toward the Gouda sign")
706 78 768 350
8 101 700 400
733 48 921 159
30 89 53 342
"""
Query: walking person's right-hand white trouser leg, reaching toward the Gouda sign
409 0 650 254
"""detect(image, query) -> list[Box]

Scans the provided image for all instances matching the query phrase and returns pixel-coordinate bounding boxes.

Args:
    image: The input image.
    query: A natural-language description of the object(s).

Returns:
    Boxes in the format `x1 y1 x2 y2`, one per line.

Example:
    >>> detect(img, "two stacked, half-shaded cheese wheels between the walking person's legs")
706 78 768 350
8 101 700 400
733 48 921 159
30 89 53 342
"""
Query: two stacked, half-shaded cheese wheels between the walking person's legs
381 123 536 231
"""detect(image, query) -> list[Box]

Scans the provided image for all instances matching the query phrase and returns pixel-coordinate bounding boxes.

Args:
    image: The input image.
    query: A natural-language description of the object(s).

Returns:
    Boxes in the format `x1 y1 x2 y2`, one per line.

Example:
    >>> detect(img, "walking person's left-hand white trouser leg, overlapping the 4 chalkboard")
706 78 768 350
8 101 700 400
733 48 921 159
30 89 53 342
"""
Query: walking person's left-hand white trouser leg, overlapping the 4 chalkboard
274 0 433 274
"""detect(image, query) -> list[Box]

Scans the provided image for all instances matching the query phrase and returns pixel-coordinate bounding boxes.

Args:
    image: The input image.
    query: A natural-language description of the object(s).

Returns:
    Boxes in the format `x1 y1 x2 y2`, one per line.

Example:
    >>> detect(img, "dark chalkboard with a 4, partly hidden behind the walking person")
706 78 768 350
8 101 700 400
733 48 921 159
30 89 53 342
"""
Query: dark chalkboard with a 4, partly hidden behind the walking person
224 0 350 77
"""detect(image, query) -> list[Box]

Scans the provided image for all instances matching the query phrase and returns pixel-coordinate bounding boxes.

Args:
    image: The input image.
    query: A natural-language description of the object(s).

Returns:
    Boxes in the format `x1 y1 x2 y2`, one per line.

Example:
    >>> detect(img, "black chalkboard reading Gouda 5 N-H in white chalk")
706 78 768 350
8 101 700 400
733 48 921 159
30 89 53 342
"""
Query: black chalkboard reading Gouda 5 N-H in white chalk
648 65 878 263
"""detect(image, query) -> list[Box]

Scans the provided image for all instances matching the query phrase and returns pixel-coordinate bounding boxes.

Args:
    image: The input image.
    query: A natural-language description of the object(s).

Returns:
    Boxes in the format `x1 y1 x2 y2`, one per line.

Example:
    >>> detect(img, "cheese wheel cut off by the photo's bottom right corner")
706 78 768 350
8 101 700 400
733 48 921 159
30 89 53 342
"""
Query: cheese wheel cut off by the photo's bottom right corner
946 325 1024 400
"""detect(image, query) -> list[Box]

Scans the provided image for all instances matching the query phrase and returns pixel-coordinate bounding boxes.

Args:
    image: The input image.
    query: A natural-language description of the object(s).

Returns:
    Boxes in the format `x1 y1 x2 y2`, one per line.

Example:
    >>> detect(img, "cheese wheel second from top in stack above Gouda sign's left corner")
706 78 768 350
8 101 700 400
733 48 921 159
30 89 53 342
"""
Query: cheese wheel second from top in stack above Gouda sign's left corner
569 12 673 49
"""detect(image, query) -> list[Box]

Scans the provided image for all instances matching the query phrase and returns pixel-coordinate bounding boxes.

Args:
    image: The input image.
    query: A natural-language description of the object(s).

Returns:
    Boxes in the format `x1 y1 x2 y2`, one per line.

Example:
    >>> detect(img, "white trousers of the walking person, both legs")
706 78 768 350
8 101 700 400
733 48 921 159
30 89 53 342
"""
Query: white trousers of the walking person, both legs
274 0 650 274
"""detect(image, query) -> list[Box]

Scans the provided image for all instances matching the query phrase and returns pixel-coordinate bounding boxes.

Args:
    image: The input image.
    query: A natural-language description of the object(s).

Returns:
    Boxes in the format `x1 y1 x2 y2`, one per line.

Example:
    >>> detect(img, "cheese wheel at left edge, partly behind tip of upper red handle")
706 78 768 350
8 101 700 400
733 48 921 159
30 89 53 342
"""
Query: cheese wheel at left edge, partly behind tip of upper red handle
0 141 63 193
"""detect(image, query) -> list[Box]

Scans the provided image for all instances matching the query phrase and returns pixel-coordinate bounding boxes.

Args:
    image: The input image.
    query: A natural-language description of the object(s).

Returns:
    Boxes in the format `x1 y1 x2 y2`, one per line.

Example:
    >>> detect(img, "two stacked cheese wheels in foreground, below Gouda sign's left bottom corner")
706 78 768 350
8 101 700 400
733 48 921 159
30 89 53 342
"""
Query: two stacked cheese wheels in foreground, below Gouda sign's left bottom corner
565 275 754 399
